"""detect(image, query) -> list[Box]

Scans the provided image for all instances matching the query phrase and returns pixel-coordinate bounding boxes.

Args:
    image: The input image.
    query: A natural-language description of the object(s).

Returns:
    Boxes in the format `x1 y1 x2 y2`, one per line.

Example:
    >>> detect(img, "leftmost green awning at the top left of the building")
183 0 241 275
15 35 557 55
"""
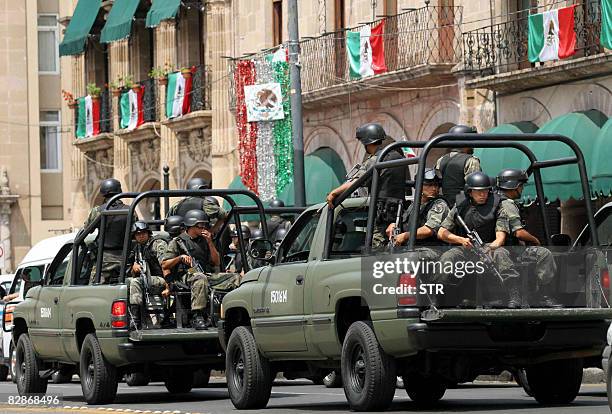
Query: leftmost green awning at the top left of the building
59 0 102 56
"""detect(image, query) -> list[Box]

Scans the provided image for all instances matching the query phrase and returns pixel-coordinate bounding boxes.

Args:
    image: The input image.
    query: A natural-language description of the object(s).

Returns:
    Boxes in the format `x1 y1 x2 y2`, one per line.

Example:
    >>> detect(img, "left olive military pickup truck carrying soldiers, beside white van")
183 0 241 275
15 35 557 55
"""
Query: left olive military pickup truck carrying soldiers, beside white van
12 190 265 404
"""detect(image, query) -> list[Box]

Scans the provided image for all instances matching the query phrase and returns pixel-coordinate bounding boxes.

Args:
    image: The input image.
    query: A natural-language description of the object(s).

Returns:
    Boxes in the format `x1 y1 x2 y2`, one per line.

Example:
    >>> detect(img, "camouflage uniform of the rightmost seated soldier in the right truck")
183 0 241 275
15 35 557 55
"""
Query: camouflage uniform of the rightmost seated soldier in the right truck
500 199 557 285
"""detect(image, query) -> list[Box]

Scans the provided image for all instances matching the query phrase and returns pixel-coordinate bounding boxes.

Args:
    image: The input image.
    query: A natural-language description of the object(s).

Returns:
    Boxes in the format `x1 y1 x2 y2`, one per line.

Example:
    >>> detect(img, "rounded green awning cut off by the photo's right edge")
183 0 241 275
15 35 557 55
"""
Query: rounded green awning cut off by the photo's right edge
587 119 612 196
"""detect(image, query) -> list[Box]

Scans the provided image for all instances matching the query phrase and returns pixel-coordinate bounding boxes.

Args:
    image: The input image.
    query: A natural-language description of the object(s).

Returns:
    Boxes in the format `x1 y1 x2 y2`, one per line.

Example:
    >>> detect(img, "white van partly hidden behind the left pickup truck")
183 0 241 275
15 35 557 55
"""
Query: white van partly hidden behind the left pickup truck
0 233 77 381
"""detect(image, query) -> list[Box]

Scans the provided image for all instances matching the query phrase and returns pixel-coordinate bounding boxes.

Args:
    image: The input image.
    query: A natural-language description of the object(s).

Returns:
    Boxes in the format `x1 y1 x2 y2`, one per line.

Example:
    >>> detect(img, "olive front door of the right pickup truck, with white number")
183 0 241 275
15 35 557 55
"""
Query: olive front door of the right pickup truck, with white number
253 211 320 352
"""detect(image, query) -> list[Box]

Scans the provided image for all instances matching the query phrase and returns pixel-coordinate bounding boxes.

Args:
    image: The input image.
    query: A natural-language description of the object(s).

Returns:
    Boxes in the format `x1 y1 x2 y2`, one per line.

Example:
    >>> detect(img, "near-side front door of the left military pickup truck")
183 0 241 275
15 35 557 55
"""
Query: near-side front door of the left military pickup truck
30 245 72 358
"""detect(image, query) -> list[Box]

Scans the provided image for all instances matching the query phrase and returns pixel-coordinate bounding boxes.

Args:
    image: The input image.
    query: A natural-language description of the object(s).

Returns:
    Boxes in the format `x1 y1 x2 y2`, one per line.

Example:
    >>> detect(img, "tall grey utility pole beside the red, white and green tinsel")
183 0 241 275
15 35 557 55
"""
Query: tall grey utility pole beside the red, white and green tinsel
287 0 306 207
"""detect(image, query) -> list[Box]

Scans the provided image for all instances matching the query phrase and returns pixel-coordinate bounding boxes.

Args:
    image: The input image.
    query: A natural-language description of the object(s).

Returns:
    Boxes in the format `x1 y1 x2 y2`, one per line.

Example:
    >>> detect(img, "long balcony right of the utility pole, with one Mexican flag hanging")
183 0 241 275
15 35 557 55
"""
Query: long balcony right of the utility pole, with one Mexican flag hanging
230 6 463 108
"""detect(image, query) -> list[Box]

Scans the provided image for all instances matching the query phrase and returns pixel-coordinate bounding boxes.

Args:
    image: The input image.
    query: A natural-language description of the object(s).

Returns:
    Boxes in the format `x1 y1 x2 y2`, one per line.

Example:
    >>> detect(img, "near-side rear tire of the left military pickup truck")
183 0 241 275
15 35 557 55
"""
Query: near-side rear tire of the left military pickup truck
79 333 119 405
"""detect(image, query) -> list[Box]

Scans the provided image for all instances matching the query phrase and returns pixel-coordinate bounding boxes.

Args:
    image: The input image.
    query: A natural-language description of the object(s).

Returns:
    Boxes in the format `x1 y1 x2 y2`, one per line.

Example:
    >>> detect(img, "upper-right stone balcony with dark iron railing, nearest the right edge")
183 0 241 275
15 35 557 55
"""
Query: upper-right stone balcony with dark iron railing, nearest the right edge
462 0 612 93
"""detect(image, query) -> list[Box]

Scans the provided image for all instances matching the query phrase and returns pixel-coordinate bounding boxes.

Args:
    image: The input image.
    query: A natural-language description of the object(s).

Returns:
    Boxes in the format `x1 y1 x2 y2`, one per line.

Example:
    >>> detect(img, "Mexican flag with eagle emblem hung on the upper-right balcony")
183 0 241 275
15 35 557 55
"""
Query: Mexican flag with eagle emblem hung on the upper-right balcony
529 6 576 62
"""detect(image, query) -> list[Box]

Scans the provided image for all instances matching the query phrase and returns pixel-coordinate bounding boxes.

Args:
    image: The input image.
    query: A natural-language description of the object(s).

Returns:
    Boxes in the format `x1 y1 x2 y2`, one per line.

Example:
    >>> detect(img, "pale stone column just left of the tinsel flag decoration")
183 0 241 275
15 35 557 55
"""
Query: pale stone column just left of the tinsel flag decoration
206 0 239 188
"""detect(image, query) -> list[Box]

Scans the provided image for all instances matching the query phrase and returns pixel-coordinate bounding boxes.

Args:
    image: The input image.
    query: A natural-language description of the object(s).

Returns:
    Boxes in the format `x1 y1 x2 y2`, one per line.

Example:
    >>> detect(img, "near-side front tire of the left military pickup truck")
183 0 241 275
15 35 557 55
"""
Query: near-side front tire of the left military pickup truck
15 333 47 395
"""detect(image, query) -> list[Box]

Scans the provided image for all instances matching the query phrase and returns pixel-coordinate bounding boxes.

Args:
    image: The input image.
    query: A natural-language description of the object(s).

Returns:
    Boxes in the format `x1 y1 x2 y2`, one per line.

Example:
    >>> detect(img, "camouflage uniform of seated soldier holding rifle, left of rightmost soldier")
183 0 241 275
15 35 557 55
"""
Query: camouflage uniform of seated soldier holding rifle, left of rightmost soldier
439 204 519 285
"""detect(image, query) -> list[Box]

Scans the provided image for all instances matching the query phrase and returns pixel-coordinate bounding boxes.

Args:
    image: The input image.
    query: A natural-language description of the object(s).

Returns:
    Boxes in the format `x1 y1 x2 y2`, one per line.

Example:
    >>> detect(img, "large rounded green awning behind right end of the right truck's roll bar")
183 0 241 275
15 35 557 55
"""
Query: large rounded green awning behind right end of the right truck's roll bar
523 109 608 201
